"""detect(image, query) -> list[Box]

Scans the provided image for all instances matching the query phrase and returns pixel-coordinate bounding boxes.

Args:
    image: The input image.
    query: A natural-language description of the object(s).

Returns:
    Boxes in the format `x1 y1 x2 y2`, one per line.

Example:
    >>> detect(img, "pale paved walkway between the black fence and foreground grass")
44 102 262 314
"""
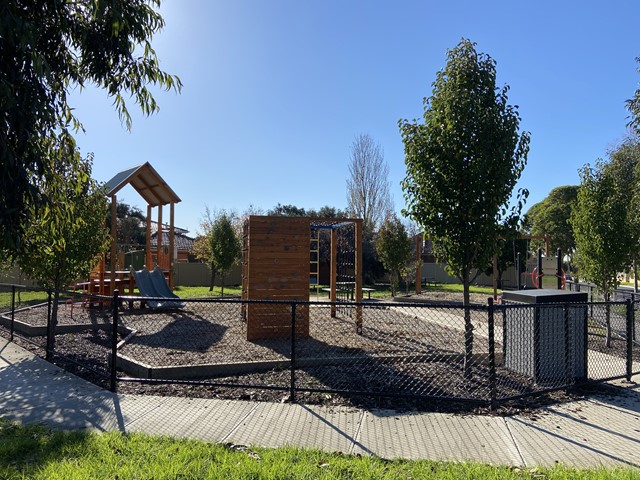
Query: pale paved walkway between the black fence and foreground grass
0 338 640 468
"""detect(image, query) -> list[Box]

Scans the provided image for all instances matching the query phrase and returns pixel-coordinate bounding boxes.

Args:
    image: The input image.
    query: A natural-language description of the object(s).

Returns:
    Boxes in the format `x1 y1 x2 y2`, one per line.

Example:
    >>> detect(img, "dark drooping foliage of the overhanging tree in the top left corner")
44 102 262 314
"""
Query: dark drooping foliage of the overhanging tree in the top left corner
0 0 182 256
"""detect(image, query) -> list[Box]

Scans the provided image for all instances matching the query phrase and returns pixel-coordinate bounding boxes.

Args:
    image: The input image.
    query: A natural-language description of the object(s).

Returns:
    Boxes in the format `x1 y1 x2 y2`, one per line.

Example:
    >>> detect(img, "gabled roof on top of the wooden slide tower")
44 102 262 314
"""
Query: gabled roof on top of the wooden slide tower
106 162 180 207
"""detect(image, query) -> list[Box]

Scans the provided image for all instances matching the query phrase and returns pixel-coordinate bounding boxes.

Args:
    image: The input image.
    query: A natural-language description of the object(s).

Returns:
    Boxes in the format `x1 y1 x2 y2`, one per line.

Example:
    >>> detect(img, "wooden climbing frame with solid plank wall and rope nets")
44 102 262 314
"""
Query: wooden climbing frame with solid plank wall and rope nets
242 215 362 340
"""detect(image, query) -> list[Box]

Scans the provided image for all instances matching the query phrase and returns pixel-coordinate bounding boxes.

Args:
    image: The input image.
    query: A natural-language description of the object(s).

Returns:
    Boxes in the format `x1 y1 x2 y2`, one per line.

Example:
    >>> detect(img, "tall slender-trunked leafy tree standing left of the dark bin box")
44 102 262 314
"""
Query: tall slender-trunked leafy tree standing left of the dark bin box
399 39 529 376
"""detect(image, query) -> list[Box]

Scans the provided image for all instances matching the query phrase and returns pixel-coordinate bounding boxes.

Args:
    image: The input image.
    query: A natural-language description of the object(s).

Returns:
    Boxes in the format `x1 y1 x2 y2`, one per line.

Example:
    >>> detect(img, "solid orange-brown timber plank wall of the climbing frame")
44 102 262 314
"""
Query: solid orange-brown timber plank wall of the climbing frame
242 216 310 340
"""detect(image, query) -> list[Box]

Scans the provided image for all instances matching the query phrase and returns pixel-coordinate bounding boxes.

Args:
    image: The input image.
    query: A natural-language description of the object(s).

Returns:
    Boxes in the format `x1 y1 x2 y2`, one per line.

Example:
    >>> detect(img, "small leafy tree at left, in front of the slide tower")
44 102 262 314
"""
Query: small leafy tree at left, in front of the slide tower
18 144 110 348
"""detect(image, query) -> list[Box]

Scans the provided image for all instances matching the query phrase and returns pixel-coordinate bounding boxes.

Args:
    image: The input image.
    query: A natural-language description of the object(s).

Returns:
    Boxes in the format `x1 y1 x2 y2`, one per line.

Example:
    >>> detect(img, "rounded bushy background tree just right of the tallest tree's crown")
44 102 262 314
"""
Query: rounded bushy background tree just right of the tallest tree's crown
524 185 578 253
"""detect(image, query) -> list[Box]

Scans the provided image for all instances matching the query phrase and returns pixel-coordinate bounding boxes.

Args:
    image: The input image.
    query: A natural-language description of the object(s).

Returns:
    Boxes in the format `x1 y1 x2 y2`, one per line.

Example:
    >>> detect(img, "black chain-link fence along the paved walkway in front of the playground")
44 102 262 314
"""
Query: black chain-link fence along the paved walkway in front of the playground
0 286 640 404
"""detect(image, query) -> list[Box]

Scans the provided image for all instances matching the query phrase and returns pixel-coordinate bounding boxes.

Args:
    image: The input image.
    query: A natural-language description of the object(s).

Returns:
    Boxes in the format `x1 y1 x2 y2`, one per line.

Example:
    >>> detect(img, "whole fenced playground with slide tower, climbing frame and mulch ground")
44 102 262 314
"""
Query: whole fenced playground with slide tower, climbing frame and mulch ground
2 163 637 412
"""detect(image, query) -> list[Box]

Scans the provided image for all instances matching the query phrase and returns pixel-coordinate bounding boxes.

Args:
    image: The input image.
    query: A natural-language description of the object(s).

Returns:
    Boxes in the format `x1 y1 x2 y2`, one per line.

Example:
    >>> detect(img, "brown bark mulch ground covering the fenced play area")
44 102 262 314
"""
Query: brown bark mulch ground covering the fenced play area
2 294 624 414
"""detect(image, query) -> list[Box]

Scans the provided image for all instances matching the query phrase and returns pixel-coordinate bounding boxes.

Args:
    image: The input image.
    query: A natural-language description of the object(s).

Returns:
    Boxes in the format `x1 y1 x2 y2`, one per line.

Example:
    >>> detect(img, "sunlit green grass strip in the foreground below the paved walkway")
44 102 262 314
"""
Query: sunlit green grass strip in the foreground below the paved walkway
0 421 637 480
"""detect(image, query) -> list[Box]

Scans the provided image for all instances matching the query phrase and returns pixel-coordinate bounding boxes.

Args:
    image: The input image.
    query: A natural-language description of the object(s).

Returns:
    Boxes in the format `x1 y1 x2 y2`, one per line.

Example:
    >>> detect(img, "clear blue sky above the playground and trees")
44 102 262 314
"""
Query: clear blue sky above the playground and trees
71 0 640 233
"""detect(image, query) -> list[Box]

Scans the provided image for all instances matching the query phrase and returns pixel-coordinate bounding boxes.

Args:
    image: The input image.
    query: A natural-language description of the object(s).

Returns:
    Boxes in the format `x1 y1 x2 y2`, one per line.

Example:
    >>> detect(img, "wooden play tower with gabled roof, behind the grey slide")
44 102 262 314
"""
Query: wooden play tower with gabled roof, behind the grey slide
88 162 180 295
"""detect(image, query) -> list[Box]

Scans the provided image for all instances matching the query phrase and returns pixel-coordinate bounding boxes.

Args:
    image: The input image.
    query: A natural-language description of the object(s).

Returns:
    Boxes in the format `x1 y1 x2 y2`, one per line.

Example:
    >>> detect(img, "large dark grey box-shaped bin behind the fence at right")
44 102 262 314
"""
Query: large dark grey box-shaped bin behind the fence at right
502 289 588 385
